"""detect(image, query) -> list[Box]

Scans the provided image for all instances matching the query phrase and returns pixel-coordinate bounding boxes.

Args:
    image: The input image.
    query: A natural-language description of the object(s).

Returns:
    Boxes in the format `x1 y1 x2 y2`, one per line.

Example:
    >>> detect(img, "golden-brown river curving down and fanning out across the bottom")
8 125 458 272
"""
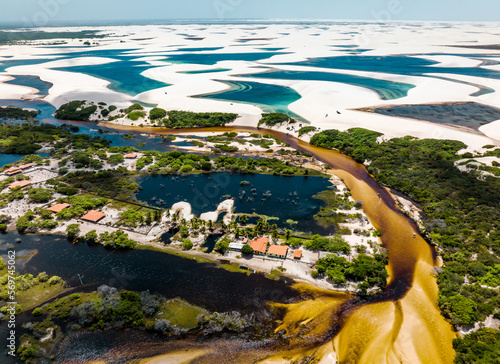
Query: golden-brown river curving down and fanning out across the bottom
94 124 456 364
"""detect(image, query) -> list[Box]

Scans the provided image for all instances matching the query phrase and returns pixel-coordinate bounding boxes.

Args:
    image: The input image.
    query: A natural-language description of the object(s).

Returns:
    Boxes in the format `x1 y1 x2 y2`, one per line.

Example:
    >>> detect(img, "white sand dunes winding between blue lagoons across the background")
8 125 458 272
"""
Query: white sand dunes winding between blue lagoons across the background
0 23 500 150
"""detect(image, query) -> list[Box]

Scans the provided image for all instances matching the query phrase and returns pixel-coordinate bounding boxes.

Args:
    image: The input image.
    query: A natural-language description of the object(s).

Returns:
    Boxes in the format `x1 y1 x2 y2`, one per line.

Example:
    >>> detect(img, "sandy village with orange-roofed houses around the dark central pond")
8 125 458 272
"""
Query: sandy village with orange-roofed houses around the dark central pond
0 132 381 290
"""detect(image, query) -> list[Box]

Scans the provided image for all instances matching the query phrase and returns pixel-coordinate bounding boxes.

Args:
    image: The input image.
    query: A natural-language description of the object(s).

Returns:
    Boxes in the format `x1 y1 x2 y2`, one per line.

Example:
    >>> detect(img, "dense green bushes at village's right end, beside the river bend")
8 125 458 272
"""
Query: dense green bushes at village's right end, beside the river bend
312 254 389 294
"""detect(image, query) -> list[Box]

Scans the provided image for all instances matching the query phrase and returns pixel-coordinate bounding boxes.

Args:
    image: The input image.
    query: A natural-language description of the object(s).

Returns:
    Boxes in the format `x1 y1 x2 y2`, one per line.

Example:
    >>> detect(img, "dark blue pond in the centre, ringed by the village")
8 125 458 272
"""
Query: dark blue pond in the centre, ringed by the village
136 173 334 234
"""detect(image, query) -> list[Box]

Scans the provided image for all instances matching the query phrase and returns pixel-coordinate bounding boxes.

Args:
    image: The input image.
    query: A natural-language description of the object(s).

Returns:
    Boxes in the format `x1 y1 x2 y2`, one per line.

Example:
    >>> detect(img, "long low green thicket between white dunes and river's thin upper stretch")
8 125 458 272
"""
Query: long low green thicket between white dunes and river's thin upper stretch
163 110 238 129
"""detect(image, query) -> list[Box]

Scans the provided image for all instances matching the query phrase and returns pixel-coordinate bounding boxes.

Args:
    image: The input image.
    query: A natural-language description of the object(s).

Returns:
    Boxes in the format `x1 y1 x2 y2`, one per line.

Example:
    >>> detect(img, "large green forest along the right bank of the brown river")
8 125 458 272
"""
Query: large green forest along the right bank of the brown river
311 129 500 326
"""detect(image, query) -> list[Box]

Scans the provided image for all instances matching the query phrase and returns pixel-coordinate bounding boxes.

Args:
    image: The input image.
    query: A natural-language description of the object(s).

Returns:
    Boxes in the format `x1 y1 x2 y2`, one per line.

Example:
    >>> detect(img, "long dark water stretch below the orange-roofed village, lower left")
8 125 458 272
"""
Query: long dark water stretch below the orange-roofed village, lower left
0 233 297 312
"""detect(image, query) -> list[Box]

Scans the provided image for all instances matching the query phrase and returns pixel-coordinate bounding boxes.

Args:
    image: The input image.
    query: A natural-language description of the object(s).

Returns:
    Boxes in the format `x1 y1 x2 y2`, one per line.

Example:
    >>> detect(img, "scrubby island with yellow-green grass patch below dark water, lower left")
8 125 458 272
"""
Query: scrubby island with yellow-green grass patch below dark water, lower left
17 285 270 363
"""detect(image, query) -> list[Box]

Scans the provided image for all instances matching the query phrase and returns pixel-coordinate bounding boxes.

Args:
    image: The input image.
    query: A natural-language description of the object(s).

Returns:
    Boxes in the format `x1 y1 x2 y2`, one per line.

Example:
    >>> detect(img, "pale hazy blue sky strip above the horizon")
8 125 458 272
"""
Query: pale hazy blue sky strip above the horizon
0 0 500 26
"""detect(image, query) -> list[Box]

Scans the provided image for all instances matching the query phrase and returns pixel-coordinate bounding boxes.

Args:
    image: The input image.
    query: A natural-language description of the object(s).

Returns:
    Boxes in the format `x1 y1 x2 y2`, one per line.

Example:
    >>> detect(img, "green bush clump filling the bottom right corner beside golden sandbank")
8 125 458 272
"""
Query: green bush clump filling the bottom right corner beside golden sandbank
453 328 500 364
